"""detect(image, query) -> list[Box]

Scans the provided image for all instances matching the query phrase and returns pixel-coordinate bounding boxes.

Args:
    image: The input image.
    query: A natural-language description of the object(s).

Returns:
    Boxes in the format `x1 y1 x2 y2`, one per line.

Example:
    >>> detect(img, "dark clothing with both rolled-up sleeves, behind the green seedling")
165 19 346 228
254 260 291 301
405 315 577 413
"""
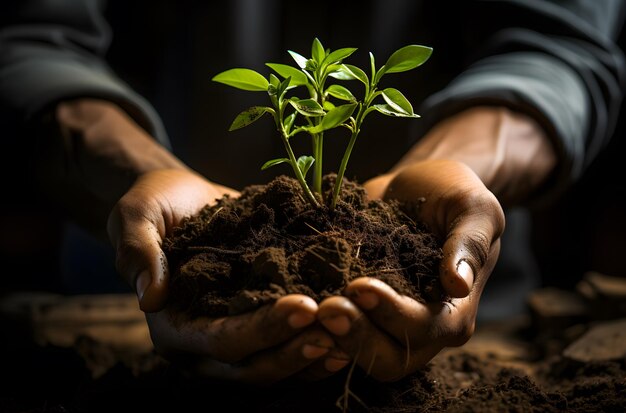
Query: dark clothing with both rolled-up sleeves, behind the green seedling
0 0 626 316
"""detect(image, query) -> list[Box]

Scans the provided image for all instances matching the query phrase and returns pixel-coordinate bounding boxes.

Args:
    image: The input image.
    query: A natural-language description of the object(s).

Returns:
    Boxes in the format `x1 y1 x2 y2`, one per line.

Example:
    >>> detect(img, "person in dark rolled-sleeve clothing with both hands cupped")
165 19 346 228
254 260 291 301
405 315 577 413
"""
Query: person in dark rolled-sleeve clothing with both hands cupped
0 0 624 383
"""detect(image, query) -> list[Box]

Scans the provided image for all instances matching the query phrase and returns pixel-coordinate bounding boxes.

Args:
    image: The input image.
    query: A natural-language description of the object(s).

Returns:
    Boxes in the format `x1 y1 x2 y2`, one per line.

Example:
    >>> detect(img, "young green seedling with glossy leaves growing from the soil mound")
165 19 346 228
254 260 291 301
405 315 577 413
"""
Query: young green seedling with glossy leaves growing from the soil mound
213 38 432 210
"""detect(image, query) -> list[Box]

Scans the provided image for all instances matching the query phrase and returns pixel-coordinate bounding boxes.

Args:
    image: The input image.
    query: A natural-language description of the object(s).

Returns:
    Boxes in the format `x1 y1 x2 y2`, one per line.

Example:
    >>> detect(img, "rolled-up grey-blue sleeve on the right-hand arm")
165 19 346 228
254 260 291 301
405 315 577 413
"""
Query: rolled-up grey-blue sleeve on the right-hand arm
421 0 626 195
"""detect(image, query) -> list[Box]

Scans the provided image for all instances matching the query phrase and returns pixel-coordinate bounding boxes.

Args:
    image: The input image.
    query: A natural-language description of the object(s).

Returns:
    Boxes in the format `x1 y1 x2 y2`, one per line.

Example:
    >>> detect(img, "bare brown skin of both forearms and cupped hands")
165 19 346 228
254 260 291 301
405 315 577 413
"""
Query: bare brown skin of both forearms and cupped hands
51 100 556 384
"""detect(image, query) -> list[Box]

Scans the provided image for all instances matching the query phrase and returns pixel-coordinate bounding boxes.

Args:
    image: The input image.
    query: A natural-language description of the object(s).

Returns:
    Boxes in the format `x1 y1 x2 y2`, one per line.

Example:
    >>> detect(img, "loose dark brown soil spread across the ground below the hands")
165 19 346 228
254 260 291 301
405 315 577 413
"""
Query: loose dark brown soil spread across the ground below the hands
0 322 626 413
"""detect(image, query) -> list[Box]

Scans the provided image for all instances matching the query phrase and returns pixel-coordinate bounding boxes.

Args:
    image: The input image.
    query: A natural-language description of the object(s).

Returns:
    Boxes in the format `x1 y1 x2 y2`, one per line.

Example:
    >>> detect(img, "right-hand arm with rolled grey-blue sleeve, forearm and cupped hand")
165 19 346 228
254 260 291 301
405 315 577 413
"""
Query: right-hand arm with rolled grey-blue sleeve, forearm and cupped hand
318 1 624 380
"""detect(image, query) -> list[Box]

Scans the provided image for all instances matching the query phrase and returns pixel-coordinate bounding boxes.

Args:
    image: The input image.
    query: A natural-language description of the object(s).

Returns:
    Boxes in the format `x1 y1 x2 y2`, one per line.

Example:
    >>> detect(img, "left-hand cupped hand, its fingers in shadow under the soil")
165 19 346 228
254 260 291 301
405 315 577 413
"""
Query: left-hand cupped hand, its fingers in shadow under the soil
108 169 347 383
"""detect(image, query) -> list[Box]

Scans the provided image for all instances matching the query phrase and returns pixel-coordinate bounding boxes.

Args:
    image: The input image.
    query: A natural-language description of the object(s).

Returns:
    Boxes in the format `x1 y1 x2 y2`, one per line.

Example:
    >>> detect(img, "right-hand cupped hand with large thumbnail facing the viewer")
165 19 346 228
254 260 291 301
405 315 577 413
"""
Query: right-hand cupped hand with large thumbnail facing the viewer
318 160 504 381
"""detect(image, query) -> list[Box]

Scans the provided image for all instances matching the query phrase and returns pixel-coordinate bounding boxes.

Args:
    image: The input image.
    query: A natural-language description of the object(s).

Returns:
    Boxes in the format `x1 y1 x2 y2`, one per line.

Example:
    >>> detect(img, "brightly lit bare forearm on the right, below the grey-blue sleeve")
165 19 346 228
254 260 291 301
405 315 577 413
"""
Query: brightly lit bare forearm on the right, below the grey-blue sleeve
368 106 557 206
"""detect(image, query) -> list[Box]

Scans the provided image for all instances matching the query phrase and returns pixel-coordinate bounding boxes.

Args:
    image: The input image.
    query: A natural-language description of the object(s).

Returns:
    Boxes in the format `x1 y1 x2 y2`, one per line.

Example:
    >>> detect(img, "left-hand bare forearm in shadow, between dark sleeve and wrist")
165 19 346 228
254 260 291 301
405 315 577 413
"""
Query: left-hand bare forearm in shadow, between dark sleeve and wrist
34 99 186 235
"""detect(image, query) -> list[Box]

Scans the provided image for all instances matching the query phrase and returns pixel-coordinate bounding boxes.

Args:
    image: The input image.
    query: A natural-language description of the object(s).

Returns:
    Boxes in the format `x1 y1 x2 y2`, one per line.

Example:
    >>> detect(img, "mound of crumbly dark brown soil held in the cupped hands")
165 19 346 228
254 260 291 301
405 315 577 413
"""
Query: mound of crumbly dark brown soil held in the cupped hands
163 175 446 317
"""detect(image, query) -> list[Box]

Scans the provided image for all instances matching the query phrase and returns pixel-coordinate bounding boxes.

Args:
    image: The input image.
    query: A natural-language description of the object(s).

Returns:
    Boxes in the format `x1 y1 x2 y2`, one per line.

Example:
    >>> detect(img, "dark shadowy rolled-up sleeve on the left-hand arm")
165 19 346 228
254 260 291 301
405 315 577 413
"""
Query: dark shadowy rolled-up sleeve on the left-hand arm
0 0 168 145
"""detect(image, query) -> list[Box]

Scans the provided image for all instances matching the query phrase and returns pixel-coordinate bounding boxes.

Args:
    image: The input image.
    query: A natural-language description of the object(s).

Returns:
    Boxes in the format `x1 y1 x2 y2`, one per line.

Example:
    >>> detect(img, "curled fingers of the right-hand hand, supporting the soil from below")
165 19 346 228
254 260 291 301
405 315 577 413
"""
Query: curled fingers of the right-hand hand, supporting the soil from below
318 278 477 381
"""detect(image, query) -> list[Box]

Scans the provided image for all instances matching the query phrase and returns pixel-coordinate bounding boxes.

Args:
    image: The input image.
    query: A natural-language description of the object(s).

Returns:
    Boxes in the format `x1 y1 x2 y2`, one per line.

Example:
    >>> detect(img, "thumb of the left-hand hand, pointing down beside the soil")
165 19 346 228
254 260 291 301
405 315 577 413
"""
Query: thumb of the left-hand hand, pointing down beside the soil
107 198 169 312
